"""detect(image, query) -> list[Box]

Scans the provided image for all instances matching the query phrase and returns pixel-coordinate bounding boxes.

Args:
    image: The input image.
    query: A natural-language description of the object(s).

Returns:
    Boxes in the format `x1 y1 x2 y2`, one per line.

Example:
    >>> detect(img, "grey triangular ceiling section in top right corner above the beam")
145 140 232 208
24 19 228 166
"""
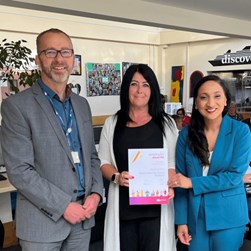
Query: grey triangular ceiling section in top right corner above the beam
143 0 251 22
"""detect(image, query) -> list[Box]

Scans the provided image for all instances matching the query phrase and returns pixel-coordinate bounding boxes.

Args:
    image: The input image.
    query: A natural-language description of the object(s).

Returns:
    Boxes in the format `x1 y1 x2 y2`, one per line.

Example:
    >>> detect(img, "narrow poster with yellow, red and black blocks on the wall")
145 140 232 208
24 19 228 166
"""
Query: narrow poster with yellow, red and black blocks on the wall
170 66 184 104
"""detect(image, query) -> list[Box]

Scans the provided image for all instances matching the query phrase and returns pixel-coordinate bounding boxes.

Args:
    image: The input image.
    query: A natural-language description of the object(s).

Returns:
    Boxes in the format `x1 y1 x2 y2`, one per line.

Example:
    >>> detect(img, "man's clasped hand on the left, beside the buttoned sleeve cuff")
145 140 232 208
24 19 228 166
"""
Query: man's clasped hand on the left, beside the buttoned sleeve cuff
63 202 86 225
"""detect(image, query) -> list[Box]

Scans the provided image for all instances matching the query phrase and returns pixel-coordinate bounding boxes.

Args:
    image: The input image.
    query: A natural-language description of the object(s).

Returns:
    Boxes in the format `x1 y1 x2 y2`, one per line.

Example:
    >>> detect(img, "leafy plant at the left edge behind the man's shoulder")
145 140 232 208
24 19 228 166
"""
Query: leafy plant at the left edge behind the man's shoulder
0 39 39 93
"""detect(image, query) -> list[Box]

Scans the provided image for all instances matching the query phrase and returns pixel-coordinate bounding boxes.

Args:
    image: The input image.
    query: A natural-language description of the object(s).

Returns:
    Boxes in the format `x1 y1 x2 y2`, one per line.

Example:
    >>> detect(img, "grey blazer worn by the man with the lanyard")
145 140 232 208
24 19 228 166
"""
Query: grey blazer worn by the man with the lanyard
1 83 103 242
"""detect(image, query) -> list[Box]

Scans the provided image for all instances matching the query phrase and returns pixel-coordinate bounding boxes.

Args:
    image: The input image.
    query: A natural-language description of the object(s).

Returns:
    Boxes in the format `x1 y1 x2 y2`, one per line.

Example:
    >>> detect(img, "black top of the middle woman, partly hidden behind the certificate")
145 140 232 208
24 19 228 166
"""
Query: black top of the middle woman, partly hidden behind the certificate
113 120 163 220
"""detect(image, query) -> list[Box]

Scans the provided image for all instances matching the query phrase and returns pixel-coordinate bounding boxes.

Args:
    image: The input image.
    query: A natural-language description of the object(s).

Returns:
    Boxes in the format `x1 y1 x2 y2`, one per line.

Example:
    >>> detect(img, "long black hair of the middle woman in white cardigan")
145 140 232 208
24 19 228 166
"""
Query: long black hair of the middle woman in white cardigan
116 64 174 135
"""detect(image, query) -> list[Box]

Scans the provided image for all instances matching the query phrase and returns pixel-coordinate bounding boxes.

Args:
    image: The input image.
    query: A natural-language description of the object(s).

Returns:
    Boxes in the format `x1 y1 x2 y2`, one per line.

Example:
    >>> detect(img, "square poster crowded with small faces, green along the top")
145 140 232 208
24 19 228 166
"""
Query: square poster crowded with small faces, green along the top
86 63 121 97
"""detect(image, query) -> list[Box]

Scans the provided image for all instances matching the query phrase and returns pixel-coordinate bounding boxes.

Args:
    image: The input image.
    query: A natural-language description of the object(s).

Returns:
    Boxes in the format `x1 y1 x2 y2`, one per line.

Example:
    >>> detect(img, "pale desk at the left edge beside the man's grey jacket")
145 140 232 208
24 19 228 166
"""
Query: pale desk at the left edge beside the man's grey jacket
0 173 16 223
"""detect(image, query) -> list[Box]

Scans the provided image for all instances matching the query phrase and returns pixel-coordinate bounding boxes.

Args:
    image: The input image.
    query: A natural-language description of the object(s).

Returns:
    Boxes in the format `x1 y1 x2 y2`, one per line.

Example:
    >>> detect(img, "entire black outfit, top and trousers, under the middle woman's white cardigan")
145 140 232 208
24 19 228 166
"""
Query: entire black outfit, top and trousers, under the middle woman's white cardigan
113 120 163 251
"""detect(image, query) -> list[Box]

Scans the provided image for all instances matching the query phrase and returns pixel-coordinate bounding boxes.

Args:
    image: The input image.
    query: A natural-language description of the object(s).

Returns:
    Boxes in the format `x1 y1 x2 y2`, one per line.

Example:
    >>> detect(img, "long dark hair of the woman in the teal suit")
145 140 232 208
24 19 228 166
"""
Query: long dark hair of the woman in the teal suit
188 75 231 165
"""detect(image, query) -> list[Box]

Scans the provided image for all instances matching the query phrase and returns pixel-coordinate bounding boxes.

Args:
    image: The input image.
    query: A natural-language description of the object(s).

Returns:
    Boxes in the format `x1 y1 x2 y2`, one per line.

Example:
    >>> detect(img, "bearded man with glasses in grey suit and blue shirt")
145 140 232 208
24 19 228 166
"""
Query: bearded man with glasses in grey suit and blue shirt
1 29 103 251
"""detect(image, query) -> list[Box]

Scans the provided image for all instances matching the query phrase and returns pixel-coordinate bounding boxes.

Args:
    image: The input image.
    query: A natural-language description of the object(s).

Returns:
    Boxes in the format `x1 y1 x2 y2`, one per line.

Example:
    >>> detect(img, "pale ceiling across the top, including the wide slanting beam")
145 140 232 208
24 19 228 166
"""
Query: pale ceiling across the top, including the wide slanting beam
0 0 251 39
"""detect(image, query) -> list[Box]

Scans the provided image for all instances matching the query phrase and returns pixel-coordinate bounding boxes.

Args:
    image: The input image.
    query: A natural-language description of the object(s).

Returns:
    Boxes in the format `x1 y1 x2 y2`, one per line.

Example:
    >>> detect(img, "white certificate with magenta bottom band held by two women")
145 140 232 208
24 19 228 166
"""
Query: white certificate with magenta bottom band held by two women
128 148 168 205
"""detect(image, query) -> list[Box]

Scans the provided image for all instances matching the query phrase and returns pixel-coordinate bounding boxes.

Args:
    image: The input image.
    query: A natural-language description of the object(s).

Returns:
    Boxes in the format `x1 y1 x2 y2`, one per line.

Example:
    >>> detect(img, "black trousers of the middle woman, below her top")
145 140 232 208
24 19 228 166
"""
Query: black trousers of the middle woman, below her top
120 217 160 251
